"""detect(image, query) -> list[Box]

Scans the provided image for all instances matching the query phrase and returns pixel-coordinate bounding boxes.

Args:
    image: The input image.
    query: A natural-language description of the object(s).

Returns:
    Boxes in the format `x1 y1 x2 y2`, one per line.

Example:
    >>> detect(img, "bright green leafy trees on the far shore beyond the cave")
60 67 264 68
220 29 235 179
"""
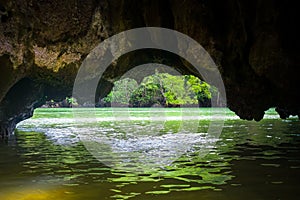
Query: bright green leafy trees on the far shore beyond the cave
103 72 217 107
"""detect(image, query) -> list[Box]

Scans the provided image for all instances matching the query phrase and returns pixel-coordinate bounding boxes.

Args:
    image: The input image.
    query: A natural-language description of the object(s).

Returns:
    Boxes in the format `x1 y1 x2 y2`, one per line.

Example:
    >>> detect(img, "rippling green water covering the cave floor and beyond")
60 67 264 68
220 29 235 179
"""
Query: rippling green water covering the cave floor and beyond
0 108 300 200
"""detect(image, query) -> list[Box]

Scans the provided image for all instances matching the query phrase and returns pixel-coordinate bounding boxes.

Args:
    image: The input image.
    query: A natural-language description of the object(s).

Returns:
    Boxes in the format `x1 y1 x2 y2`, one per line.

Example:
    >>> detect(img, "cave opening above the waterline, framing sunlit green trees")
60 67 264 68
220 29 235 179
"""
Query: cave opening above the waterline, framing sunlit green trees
42 68 226 108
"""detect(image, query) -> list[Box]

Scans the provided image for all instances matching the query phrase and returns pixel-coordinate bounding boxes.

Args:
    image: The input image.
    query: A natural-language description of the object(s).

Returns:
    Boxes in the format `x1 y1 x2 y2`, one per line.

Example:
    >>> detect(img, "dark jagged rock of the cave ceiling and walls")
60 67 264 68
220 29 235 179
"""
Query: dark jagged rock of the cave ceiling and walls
0 0 300 136
